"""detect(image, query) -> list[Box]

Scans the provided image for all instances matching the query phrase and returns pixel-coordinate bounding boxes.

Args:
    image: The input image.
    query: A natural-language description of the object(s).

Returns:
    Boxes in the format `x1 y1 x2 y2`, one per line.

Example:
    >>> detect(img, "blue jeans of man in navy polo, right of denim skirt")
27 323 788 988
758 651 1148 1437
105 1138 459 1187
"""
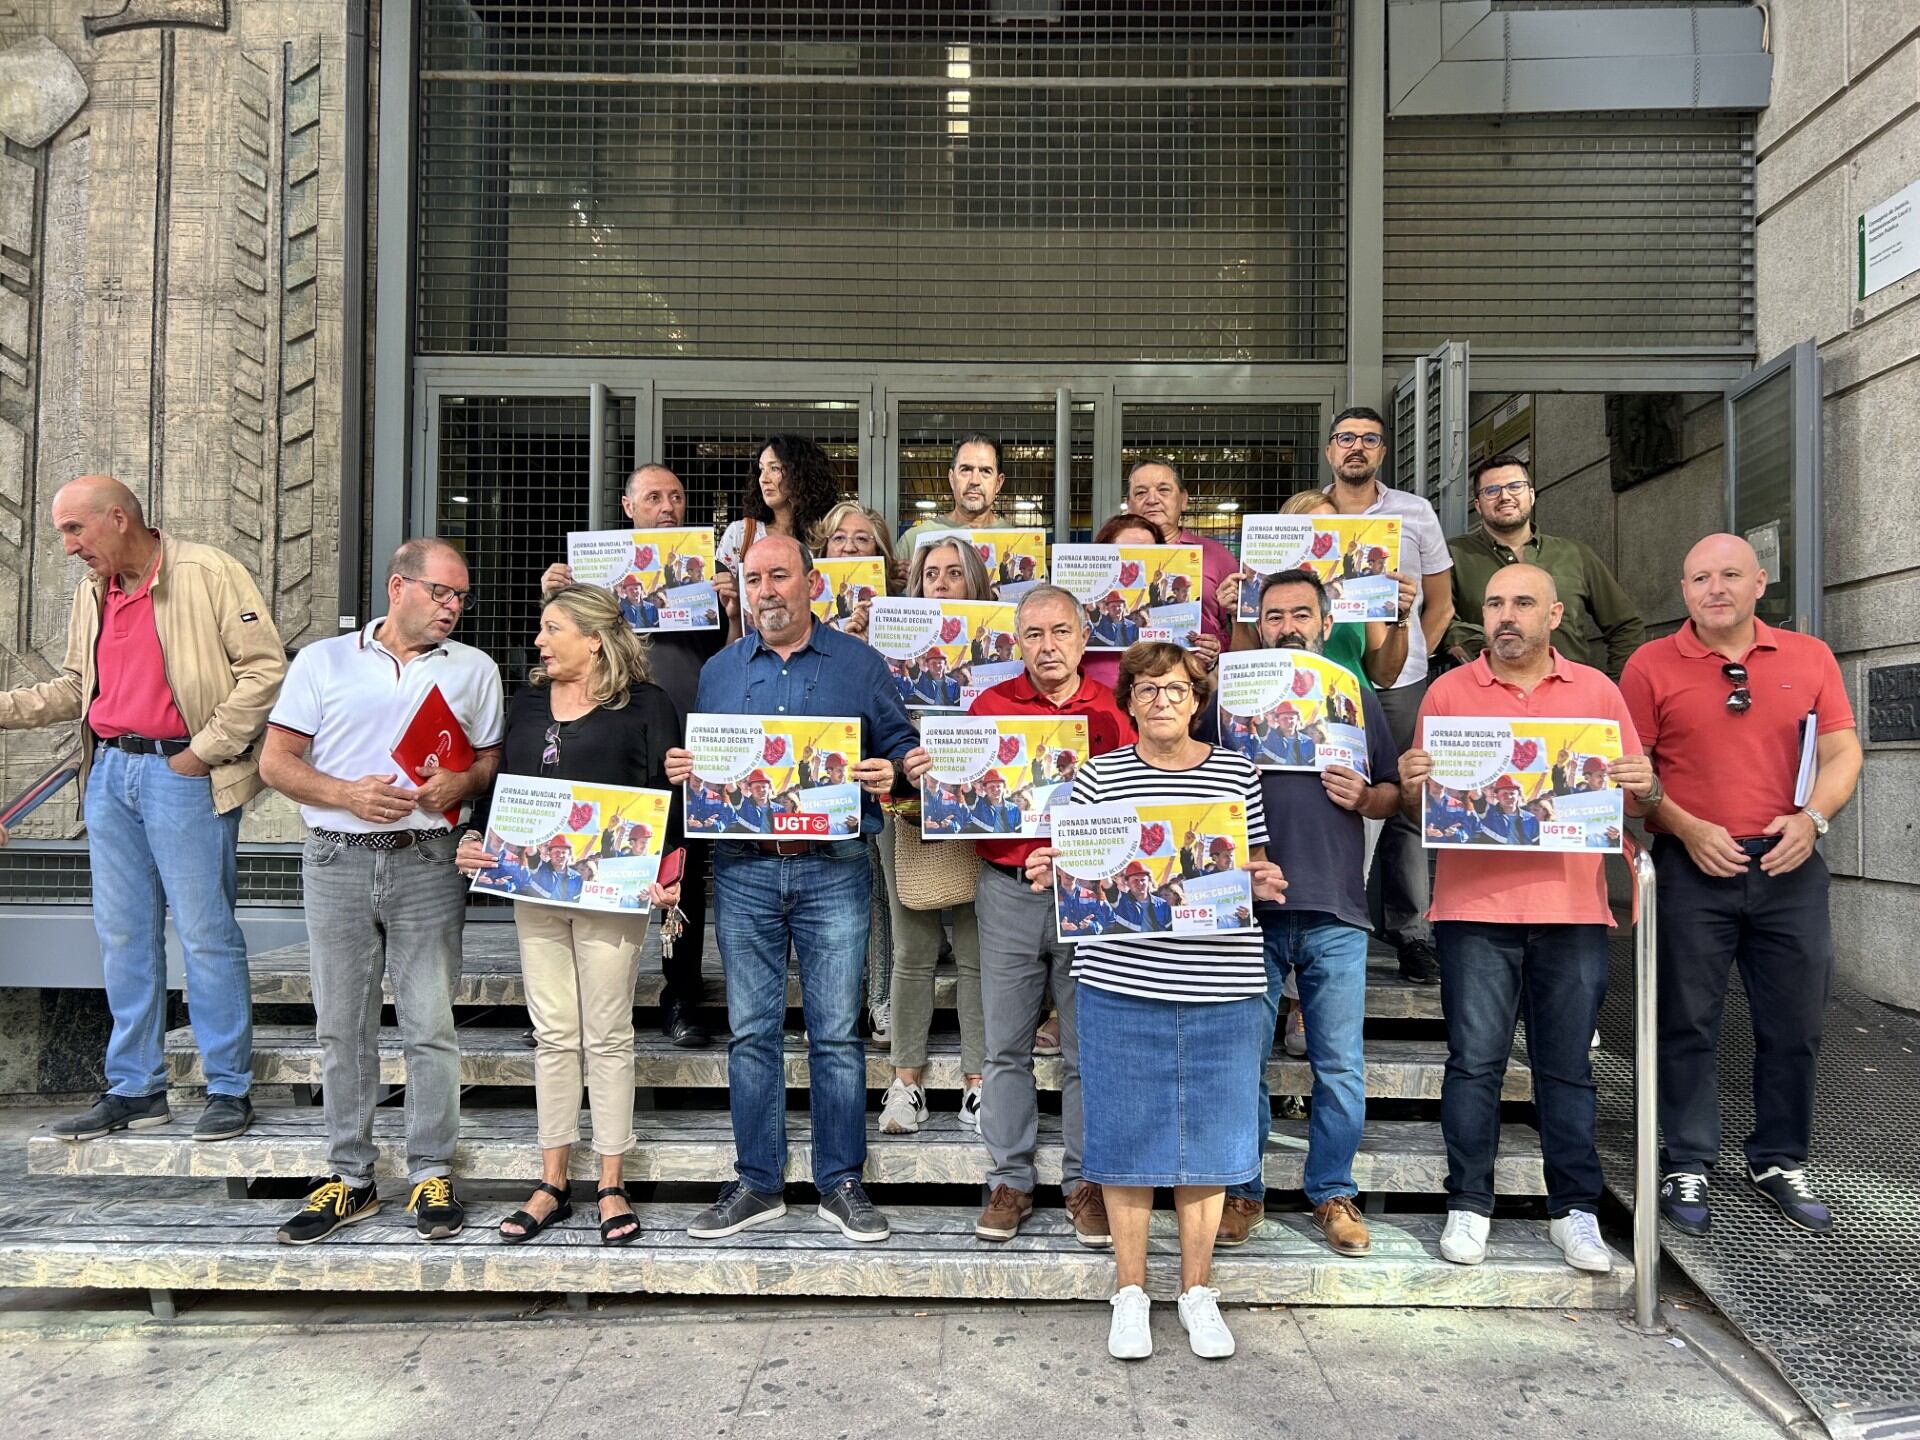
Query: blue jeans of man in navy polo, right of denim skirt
1227 910 1367 1206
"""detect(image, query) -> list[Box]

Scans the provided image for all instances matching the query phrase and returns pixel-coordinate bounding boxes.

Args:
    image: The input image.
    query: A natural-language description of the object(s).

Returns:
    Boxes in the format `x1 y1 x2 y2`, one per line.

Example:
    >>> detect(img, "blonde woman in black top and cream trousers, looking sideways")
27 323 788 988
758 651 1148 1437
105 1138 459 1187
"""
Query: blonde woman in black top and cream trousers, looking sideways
455 586 680 1244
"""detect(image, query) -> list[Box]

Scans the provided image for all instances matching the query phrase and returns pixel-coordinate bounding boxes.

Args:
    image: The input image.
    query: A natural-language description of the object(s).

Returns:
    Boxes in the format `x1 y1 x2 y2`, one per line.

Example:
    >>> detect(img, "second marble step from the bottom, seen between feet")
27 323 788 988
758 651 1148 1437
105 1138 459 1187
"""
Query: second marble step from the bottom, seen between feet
27 1106 1546 1194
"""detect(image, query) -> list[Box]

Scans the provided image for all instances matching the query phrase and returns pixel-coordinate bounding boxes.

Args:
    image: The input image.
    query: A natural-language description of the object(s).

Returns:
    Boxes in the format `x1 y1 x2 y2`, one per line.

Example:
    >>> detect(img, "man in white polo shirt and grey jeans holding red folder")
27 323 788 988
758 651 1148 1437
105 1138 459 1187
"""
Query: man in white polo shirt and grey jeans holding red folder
259 540 503 1244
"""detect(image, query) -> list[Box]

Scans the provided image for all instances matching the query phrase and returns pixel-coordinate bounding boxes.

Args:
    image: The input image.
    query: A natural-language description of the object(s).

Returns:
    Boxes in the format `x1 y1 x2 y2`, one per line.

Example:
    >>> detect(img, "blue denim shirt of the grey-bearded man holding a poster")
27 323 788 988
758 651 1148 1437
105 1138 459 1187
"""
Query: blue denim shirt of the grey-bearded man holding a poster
693 622 920 835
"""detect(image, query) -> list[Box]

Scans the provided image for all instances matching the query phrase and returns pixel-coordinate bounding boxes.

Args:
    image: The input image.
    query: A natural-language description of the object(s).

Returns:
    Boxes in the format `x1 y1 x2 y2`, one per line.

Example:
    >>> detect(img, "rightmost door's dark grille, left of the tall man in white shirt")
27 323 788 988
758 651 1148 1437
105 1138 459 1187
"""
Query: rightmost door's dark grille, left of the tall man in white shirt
1119 405 1321 555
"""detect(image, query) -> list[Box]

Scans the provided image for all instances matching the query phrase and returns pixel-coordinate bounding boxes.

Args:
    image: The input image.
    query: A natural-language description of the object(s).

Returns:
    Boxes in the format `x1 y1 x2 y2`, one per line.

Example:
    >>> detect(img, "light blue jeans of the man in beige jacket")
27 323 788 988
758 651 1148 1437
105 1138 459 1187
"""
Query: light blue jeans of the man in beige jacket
84 745 253 1096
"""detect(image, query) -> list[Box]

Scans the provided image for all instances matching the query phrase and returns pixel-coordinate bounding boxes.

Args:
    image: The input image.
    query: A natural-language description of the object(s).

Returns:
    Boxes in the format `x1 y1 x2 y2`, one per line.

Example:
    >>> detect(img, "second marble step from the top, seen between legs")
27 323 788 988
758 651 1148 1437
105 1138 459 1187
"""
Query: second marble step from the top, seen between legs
167 1025 1532 1100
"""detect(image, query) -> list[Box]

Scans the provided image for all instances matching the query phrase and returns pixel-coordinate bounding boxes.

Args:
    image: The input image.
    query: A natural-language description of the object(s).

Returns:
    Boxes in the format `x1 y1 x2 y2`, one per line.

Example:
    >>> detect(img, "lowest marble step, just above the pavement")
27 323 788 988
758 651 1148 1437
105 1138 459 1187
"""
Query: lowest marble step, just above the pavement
0 1190 1632 1313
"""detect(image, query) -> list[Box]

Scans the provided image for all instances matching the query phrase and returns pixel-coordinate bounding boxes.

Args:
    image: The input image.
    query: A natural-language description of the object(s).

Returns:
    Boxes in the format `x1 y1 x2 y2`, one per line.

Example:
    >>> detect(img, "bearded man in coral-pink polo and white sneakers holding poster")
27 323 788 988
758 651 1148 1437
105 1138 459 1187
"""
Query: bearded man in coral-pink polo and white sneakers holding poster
1400 564 1653 1271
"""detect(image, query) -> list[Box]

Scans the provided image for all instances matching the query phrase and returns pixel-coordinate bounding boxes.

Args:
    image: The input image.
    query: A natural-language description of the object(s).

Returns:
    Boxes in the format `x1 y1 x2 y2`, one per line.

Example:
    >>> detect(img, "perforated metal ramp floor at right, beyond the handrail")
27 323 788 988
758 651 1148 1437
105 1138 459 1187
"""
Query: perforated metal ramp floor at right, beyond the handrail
1594 936 1920 1432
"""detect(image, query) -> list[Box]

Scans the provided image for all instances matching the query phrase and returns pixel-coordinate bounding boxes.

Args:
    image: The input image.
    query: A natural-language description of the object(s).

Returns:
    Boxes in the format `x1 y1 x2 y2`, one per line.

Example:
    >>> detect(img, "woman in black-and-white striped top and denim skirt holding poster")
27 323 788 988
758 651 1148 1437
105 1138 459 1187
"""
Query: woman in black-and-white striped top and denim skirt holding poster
1027 643 1286 1359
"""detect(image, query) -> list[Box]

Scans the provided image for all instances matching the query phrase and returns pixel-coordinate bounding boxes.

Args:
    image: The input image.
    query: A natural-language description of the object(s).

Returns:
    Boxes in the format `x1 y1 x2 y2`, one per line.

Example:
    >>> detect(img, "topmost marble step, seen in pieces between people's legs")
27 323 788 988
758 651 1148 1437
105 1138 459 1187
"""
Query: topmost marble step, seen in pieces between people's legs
248 924 1440 1020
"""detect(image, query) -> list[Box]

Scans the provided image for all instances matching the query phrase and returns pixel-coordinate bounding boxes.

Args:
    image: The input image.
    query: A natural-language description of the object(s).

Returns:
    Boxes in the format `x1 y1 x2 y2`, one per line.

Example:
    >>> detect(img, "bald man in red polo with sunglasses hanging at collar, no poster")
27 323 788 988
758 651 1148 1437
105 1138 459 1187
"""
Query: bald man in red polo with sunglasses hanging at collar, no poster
1620 536 1860 1235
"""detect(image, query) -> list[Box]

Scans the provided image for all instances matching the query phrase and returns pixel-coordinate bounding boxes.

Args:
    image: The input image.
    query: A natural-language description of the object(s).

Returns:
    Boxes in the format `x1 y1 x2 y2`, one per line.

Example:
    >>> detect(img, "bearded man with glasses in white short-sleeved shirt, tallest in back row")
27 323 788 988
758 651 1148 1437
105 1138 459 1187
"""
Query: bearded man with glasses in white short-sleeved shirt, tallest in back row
1327 405 1453 985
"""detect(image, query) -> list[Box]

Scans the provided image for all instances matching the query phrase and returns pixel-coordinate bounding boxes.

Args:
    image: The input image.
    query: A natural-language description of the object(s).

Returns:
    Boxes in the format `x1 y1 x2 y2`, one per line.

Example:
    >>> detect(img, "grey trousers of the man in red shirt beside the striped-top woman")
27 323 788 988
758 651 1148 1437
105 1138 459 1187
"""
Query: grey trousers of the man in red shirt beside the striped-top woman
973 866 1083 1194
